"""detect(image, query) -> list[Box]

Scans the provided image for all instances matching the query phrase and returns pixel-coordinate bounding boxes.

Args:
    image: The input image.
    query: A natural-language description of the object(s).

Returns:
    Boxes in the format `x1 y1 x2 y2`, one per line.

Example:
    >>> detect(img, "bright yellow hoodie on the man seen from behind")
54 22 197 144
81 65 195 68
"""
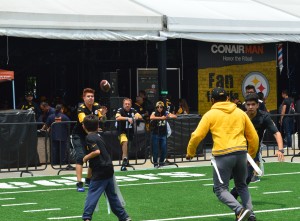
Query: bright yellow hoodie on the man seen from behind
187 101 259 158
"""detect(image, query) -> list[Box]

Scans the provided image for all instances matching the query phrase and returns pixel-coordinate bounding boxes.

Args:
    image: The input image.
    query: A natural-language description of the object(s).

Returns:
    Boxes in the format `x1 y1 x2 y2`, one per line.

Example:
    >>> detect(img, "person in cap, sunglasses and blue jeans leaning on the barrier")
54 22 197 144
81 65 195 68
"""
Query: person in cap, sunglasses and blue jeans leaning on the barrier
150 101 177 168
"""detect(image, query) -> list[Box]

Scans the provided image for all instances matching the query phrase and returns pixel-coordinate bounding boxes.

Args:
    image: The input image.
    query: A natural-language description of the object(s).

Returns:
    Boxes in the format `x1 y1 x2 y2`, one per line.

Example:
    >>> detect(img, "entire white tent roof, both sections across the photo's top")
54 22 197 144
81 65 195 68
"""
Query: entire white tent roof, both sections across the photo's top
0 0 300 43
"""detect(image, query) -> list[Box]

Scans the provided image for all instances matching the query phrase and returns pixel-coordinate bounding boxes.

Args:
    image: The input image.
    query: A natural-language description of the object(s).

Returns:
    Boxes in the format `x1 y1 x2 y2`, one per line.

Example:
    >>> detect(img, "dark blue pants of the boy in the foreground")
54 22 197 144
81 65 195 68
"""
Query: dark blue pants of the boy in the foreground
82 177 128 220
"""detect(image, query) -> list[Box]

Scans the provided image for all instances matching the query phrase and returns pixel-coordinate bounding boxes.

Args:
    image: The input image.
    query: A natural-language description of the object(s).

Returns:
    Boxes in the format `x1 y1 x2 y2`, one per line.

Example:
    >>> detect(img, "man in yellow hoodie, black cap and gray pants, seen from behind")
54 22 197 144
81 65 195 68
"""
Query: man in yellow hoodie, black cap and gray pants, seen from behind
186 87 259 221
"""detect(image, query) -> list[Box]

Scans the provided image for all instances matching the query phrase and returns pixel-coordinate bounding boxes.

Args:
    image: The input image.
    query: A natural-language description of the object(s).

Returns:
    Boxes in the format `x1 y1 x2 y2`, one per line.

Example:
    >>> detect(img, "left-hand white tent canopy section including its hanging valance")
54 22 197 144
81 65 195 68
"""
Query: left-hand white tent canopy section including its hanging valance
0 0 166 41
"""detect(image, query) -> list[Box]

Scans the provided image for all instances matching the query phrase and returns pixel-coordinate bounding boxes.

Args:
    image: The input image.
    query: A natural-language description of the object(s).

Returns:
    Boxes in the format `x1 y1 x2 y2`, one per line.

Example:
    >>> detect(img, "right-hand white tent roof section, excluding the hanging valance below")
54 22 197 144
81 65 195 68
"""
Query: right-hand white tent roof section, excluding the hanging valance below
137 0 300 34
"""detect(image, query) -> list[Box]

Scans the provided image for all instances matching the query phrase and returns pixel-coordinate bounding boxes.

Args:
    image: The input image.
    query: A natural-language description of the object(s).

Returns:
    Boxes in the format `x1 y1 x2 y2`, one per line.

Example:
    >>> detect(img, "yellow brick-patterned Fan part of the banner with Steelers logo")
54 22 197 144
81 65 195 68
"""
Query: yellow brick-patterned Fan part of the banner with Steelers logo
198 60 277 115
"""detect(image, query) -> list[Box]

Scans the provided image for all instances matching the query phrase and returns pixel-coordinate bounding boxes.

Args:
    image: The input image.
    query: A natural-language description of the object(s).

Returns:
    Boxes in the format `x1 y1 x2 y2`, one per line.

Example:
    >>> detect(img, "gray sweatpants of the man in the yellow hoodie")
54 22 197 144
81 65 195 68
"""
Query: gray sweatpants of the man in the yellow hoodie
213 152 253 214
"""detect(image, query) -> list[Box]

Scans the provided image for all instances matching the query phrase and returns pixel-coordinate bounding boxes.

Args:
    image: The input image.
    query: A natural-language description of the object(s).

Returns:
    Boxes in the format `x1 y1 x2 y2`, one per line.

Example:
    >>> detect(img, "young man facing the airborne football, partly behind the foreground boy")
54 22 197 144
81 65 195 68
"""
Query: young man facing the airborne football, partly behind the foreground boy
71 88 107 192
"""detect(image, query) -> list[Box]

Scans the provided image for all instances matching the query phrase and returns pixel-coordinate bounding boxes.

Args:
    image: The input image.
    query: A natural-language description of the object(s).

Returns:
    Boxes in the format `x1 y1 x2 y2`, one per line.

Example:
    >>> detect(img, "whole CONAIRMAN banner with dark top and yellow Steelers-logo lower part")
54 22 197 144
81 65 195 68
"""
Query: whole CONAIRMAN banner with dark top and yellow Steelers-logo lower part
198 43 277 115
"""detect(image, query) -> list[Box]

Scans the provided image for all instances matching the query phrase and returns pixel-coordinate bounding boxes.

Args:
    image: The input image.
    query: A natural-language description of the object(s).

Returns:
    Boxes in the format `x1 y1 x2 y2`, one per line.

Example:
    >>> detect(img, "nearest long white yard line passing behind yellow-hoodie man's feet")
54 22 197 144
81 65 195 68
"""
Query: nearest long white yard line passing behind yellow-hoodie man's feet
143 207 300 221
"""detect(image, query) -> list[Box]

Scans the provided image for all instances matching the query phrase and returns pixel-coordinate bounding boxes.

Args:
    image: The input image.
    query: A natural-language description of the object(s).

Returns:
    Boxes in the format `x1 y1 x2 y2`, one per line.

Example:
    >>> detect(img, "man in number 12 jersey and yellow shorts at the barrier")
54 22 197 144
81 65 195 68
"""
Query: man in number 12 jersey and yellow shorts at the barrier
116 98 143 171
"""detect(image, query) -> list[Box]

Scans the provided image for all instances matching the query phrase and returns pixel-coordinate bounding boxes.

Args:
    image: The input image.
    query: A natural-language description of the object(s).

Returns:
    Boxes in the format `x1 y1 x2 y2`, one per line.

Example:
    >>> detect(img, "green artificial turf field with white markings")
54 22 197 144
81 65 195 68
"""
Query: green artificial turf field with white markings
0 163 300 221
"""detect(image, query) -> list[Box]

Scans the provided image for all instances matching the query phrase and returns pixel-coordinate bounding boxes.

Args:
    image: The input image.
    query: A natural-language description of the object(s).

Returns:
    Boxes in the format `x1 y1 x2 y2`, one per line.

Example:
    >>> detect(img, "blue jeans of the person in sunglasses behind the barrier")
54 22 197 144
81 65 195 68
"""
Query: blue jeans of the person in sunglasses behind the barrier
152 133 167 164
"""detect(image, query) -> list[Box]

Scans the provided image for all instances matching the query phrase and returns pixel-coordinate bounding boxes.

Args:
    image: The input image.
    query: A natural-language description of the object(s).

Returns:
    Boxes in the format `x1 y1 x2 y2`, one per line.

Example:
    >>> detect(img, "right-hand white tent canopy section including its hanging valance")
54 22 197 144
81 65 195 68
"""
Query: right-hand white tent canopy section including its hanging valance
136 0 300 44
